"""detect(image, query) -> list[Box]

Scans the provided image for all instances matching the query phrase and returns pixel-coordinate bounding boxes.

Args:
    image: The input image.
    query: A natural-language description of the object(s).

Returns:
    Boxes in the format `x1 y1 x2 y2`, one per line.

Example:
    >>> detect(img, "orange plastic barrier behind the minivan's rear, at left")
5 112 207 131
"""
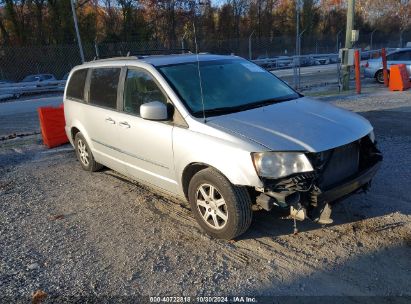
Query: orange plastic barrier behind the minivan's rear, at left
38 106 68 148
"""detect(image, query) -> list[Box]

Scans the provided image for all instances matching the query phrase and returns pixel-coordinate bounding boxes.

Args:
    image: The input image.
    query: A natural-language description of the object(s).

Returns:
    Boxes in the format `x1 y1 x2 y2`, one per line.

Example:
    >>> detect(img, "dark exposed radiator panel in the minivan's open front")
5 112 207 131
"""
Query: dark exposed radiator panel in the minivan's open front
320 142 360 189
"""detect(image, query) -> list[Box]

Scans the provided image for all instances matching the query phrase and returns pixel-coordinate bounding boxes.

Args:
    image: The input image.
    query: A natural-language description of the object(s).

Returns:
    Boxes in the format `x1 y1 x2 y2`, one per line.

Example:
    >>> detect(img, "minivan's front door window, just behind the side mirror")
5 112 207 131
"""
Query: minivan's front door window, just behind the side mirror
124 69 167 115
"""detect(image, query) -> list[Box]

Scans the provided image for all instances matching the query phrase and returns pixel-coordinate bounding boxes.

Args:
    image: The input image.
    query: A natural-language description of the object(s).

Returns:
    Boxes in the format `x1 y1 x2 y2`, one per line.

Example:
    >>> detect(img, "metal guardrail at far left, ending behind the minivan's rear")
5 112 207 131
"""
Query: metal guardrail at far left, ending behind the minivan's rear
0 80 66 100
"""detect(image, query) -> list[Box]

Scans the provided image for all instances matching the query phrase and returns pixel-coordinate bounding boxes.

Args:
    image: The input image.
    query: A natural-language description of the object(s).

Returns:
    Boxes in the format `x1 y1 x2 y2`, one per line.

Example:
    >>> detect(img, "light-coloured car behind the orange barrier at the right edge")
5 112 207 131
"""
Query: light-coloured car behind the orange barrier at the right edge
364 48 411 83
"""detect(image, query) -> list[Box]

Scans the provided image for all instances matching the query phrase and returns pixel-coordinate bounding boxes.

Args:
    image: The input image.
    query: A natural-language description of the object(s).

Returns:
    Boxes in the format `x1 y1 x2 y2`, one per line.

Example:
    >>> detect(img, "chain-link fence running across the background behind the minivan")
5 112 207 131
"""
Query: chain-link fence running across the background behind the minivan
0 31 411 95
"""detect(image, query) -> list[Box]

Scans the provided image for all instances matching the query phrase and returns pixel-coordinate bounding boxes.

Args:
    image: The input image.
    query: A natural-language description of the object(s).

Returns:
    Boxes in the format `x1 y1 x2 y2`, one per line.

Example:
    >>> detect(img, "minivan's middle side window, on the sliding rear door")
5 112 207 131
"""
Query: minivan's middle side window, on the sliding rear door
89 68 121 109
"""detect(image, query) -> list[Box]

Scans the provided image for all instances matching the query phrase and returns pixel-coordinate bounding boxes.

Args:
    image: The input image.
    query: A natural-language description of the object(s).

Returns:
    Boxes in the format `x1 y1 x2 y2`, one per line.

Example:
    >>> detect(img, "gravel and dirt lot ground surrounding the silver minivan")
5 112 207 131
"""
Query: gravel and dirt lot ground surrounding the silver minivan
0 91 411 303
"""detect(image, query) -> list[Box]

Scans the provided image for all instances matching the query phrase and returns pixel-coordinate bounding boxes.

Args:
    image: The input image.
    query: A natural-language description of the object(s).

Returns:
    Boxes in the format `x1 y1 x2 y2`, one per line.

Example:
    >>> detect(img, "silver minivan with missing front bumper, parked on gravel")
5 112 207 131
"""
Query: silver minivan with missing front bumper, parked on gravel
64 54 382 239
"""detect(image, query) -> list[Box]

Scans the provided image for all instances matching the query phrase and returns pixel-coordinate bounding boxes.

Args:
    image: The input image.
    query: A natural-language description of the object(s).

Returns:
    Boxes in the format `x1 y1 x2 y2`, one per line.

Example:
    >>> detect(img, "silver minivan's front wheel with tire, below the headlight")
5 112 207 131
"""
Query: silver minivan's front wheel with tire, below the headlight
188 168 252 240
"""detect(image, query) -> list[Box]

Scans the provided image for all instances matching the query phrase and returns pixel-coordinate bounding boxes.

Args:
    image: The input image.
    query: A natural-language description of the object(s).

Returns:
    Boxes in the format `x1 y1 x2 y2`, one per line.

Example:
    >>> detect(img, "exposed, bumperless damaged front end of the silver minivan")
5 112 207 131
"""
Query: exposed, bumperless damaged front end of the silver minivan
256 136 382 224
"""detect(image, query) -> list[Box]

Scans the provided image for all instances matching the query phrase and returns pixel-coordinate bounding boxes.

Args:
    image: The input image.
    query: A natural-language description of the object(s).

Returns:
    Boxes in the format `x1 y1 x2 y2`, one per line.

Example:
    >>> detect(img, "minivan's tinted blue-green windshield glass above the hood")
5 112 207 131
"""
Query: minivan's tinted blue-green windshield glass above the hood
158 59 299 117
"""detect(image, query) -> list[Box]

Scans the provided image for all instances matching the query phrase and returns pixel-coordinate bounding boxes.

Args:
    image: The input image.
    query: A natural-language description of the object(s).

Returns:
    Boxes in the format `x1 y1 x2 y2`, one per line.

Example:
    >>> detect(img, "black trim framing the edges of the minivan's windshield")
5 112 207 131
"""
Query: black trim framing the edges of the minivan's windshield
154 58 304 118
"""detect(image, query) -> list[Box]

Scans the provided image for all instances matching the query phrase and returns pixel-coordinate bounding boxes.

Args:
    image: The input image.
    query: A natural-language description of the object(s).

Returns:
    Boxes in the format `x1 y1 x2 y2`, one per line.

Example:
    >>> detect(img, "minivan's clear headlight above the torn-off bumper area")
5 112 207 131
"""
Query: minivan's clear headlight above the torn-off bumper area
251 152 313 178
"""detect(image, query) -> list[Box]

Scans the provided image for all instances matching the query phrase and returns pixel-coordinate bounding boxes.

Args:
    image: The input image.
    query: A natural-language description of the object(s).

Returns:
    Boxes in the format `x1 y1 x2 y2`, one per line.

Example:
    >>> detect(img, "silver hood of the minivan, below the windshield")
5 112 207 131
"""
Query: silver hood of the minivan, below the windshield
207 97 373 152
